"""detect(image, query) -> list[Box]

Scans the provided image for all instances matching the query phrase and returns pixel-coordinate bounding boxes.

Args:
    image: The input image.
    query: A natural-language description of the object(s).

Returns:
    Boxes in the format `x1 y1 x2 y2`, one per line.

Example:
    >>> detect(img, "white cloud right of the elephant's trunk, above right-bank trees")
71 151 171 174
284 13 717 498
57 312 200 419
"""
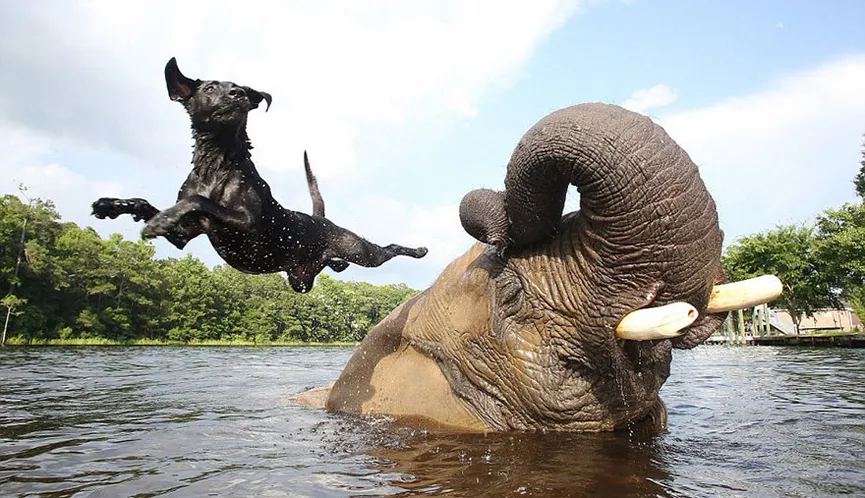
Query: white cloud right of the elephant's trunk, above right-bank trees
659 54 865 247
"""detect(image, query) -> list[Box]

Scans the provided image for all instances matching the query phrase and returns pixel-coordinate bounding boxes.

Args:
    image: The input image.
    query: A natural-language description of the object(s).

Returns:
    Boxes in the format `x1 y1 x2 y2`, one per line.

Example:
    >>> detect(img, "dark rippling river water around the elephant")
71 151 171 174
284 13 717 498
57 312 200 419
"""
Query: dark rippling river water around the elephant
0 346 865 497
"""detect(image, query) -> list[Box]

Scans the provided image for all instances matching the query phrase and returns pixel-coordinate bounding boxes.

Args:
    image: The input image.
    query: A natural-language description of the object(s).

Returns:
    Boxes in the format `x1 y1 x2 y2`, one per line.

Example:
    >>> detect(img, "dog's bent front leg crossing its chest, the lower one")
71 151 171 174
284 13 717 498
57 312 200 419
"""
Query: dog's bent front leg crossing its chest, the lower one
141 195 257 239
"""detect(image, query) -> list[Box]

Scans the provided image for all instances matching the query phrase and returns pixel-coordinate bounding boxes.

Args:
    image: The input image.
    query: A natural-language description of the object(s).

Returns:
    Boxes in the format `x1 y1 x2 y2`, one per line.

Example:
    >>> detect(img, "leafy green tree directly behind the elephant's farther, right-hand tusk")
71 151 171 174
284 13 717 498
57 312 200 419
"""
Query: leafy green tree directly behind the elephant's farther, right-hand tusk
724 225 841 333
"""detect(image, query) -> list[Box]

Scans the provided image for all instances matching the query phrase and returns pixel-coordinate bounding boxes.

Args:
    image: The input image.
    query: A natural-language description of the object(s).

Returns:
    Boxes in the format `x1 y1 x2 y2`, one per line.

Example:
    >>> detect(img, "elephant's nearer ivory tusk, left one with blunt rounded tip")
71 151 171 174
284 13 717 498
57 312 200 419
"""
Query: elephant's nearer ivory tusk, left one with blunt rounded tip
616 302 699 341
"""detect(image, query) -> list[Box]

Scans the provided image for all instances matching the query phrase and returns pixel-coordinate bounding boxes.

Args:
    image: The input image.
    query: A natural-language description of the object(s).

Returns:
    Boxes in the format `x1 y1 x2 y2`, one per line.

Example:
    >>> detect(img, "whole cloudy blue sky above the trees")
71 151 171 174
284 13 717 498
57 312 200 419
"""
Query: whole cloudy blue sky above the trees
0 0 865 289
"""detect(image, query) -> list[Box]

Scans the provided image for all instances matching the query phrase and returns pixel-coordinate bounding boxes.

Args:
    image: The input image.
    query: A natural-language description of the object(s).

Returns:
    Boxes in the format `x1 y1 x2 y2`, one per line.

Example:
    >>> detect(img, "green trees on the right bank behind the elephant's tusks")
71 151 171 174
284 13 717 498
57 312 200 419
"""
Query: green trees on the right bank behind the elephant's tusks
724 136 865 329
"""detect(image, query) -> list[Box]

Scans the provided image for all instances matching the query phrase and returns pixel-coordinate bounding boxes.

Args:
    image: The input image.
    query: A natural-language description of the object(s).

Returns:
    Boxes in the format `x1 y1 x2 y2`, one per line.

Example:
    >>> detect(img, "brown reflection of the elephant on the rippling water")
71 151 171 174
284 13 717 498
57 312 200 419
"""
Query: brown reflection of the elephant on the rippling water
371 426 669 497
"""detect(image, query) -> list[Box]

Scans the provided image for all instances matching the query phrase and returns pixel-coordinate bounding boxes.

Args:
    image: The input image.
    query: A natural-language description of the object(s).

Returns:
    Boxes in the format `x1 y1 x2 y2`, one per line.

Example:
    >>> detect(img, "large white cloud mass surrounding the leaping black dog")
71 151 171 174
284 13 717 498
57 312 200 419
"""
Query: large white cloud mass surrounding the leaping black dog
0 0 578 287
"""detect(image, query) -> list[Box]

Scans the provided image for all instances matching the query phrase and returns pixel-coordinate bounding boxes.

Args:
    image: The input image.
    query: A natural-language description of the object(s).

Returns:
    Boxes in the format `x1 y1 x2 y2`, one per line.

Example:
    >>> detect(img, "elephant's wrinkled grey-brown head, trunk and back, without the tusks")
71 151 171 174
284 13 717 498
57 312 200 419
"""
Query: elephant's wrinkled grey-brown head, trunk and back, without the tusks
326 104 724 431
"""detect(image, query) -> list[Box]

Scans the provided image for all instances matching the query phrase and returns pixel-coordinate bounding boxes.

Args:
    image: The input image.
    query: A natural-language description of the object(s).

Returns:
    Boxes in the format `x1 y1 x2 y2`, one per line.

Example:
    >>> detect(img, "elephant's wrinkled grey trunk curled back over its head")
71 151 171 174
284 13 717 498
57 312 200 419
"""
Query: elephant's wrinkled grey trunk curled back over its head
460 103 724 347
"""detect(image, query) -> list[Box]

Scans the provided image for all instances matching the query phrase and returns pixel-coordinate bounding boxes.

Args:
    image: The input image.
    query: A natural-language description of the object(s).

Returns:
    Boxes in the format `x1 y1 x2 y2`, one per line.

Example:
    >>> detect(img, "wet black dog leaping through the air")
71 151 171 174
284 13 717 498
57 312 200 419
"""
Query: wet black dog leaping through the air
93 58 427 292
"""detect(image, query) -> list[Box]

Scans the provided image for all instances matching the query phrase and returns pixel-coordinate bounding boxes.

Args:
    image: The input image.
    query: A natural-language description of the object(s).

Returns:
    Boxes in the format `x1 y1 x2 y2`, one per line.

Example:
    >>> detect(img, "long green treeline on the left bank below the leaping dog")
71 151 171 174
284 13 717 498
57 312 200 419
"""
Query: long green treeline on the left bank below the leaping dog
0 195 417 343
